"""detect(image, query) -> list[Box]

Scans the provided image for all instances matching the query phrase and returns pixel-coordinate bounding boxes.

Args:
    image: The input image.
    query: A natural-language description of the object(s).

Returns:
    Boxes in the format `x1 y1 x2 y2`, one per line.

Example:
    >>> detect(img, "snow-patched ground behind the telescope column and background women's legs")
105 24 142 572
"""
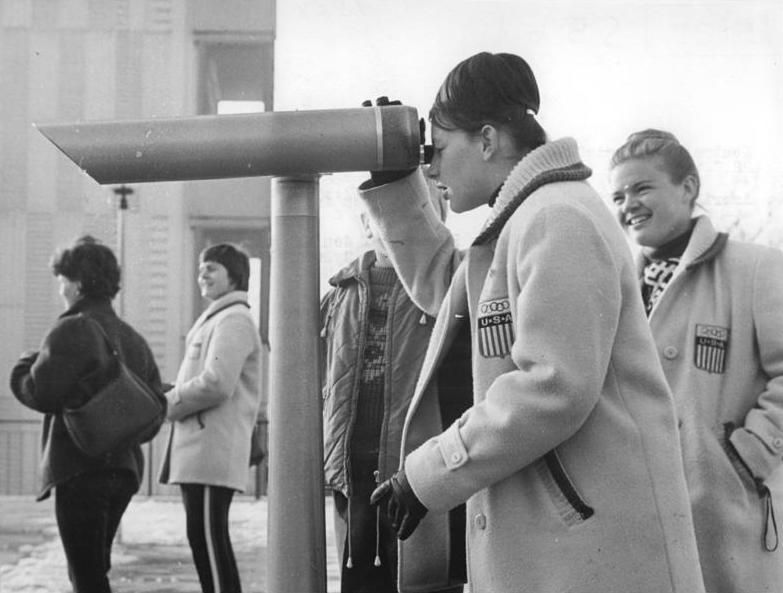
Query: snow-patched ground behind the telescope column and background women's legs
0 497 339 593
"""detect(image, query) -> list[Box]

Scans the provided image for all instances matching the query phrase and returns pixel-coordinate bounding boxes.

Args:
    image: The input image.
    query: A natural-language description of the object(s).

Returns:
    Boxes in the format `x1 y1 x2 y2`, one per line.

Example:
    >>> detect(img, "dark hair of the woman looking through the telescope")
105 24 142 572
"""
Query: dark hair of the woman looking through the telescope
429 52 546 150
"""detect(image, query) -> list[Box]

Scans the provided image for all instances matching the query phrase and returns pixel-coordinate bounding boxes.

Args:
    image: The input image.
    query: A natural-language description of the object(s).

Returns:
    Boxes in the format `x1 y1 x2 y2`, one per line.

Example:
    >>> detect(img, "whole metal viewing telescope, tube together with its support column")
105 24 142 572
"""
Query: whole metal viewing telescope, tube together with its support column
37 105 427 593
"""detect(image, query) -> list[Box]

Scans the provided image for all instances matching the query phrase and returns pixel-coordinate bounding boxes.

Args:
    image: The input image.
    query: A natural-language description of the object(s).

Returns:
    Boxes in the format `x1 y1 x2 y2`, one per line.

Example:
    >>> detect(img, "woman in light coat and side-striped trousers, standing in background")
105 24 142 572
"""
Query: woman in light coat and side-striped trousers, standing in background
159 244 261 593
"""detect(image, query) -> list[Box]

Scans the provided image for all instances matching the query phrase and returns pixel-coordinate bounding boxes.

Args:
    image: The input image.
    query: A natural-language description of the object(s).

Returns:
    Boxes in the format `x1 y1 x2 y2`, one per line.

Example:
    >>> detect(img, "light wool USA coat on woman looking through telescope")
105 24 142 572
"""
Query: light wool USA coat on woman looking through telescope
363 139 704 593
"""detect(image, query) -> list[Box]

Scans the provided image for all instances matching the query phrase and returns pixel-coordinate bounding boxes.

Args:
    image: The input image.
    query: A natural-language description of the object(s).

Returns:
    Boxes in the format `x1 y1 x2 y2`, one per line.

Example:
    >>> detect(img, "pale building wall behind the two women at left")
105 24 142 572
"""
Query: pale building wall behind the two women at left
0 0 275 494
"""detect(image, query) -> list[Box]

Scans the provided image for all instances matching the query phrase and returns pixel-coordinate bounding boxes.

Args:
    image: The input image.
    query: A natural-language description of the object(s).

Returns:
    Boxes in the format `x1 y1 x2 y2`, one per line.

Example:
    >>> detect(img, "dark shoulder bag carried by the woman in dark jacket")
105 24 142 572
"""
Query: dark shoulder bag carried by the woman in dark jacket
62 318 166 457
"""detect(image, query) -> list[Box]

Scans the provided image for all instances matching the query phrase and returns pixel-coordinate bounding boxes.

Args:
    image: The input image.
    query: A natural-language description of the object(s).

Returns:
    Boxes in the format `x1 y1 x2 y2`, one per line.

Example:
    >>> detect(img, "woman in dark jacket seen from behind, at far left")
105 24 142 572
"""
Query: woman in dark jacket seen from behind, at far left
11 236 164 593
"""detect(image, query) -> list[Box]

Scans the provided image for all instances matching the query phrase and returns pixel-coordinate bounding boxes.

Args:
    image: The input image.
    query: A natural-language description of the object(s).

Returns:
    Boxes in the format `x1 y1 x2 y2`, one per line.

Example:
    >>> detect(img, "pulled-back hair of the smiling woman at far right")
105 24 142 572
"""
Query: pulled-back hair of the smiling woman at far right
609 128 701 197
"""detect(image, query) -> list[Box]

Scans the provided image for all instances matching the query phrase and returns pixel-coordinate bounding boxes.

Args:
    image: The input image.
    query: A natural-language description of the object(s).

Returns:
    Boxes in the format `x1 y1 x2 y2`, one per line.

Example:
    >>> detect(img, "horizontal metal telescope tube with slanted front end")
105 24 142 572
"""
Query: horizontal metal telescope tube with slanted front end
35 105 420 184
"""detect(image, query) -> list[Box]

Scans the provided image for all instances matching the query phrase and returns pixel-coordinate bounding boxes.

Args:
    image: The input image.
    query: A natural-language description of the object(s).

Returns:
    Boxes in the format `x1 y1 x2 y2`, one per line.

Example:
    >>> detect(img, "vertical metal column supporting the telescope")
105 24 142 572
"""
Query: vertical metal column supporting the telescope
266 176 326 593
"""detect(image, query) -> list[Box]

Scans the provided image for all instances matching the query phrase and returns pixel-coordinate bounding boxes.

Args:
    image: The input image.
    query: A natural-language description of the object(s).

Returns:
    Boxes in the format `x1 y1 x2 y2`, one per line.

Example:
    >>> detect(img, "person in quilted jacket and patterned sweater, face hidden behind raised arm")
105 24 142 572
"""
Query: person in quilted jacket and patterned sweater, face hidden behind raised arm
321 192 461 593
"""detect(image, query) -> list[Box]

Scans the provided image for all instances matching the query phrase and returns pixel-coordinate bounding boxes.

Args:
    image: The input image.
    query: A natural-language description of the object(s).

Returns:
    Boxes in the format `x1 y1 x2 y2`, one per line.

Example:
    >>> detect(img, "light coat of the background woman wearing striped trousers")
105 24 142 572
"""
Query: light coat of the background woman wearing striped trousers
159 291 261 492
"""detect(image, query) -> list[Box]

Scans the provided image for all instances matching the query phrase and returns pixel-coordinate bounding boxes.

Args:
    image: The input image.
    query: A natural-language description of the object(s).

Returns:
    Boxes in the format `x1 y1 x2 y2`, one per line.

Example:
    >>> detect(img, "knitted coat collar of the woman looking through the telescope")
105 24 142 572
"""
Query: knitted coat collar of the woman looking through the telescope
473 138 593 245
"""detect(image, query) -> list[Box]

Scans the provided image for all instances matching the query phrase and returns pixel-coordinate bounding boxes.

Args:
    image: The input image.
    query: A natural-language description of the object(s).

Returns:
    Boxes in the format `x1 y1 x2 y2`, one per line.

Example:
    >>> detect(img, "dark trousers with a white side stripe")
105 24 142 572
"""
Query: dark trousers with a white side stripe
180 484 242 593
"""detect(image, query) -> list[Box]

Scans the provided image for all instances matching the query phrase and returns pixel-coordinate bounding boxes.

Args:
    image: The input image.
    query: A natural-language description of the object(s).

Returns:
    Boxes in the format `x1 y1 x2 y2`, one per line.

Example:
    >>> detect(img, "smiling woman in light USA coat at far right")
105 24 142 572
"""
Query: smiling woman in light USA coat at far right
610 129 783 593
